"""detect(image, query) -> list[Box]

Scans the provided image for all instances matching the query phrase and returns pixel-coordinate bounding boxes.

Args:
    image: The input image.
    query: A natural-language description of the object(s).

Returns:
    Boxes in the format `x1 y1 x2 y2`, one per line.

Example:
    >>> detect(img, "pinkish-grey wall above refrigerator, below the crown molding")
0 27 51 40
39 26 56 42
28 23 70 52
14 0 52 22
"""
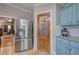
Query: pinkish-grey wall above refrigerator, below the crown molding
0 3 32 20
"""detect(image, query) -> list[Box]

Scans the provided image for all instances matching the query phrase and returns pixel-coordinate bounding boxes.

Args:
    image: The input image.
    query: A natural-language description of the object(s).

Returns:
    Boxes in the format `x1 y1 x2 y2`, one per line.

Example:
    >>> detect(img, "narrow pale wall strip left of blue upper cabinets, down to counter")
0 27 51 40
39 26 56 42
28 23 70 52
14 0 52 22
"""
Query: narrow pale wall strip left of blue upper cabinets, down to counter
56 4 63 36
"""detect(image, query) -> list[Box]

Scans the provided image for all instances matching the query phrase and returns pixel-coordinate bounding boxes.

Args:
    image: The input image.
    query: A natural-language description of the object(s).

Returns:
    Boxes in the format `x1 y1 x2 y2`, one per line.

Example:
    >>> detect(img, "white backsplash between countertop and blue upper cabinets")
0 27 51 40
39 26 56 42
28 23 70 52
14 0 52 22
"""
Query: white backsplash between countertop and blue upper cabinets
56 26 79 37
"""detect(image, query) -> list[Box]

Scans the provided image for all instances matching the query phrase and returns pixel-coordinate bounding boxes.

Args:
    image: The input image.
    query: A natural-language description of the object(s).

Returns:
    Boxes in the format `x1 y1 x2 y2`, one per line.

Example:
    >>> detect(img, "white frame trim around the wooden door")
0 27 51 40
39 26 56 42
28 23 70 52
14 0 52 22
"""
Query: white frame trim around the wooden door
34 10 52 53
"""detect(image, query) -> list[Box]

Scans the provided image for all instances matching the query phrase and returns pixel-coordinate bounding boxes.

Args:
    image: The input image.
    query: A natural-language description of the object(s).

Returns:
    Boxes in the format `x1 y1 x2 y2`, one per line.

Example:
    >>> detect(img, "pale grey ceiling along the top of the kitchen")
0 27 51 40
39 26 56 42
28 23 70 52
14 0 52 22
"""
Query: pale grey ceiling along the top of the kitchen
8 3 67 11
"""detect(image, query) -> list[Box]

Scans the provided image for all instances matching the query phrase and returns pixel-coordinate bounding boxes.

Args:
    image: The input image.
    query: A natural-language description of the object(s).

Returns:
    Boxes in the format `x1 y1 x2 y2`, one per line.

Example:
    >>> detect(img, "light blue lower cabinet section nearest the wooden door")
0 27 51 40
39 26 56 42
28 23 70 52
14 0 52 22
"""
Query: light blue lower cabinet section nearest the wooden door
56 38 69 55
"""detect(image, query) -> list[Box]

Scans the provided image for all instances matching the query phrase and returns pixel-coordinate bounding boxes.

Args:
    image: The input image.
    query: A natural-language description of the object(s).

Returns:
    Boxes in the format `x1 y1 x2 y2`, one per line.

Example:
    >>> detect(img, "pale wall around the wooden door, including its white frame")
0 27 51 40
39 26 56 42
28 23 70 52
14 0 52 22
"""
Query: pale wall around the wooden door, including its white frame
34 3 56 54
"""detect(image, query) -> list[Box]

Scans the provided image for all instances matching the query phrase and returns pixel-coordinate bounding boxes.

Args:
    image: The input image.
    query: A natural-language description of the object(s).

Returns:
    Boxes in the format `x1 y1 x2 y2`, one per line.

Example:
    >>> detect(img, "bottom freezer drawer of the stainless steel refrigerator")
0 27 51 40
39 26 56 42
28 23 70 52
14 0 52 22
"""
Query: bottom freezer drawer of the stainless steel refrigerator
15 39 32 51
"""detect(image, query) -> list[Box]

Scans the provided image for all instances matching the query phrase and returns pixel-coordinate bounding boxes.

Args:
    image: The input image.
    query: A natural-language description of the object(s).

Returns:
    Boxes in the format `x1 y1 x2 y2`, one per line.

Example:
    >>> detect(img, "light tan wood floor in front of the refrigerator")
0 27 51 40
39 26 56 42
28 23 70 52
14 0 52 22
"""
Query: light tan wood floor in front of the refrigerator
0 46 49 55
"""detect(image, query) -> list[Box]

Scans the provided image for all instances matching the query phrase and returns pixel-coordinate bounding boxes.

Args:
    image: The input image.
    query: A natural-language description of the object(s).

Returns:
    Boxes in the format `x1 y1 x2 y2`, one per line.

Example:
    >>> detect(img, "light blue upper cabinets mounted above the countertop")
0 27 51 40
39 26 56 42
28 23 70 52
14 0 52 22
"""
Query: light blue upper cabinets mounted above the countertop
60 3 79 25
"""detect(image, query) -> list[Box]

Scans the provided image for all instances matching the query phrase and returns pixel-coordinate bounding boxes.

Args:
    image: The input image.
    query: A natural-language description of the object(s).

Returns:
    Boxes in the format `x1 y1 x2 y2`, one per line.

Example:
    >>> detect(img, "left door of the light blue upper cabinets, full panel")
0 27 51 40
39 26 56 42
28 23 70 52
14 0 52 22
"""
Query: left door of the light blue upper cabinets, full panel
60 5 72 25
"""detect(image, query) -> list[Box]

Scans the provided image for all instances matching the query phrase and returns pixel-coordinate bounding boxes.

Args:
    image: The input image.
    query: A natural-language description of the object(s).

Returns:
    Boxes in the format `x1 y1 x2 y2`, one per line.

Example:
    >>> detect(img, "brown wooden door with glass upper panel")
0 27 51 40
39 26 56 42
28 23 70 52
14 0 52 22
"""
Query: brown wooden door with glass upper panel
37 12 50 52
